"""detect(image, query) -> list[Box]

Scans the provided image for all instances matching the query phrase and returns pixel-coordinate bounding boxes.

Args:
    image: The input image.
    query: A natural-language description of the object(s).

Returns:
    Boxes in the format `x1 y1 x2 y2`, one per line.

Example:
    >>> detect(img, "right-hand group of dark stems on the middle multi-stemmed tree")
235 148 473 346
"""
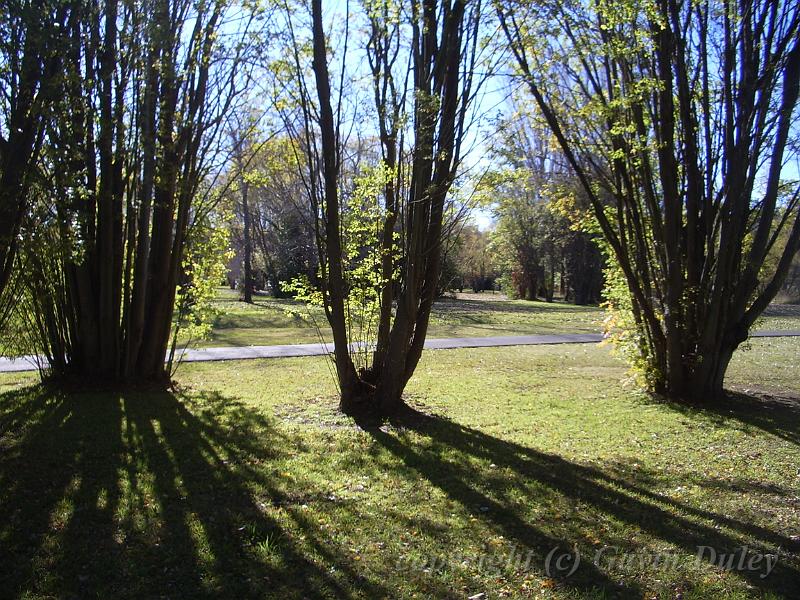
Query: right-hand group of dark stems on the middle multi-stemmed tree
368 1 481 412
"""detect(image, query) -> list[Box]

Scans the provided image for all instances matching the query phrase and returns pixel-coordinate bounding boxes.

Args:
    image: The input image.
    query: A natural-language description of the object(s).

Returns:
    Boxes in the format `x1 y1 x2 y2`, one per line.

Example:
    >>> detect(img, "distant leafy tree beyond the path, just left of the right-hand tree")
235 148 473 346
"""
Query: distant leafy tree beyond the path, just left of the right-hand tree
483 108 603 304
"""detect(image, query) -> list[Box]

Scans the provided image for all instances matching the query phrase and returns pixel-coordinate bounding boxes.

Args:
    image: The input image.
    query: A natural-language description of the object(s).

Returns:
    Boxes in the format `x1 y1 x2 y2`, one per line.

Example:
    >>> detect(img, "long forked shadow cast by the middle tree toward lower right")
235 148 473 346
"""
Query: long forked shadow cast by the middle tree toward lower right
361 409 800 598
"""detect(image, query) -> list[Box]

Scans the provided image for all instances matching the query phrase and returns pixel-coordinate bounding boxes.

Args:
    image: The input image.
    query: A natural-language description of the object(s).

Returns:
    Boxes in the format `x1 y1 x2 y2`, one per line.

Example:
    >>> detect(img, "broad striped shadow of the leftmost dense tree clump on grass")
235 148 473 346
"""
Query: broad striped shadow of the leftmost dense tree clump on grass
0 386 388 598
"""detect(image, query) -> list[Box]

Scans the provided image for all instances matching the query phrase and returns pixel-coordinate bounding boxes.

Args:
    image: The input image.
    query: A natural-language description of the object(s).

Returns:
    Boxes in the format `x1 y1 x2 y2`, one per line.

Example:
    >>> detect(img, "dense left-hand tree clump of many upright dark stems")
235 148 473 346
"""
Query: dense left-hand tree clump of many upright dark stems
21 0 253 382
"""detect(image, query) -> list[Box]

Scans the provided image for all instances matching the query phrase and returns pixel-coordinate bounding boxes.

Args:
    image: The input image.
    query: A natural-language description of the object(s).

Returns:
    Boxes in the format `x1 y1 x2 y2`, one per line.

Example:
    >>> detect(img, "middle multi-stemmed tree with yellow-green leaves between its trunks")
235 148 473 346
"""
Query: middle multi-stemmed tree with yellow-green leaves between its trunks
284 0 481 414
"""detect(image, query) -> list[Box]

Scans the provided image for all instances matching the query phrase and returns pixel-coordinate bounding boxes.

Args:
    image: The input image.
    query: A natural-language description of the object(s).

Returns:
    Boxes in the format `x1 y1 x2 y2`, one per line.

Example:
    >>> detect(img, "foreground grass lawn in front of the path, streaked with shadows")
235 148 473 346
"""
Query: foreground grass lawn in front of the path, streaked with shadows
0 338 800 600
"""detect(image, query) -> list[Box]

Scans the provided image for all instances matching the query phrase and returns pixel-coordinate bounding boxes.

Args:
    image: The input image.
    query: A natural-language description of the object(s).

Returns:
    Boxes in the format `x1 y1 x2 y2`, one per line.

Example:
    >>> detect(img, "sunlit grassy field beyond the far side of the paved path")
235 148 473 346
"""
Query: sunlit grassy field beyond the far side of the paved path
195 288 800 346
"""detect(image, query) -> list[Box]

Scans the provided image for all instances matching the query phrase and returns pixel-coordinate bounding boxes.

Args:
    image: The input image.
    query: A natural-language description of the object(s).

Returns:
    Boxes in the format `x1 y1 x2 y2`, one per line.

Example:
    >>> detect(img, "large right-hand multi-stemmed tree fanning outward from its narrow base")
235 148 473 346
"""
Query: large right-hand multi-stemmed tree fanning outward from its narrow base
497 0 800 401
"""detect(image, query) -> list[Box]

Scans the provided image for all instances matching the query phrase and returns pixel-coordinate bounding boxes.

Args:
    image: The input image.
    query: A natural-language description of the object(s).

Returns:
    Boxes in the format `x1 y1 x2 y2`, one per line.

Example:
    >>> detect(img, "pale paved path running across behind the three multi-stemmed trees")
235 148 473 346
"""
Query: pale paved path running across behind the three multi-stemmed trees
0 330 800 373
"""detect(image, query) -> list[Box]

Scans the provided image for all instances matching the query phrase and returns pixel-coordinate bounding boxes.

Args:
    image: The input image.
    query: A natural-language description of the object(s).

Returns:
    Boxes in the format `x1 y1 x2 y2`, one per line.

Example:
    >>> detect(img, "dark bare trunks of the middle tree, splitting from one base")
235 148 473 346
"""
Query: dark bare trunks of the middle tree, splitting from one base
298 0 478 415
